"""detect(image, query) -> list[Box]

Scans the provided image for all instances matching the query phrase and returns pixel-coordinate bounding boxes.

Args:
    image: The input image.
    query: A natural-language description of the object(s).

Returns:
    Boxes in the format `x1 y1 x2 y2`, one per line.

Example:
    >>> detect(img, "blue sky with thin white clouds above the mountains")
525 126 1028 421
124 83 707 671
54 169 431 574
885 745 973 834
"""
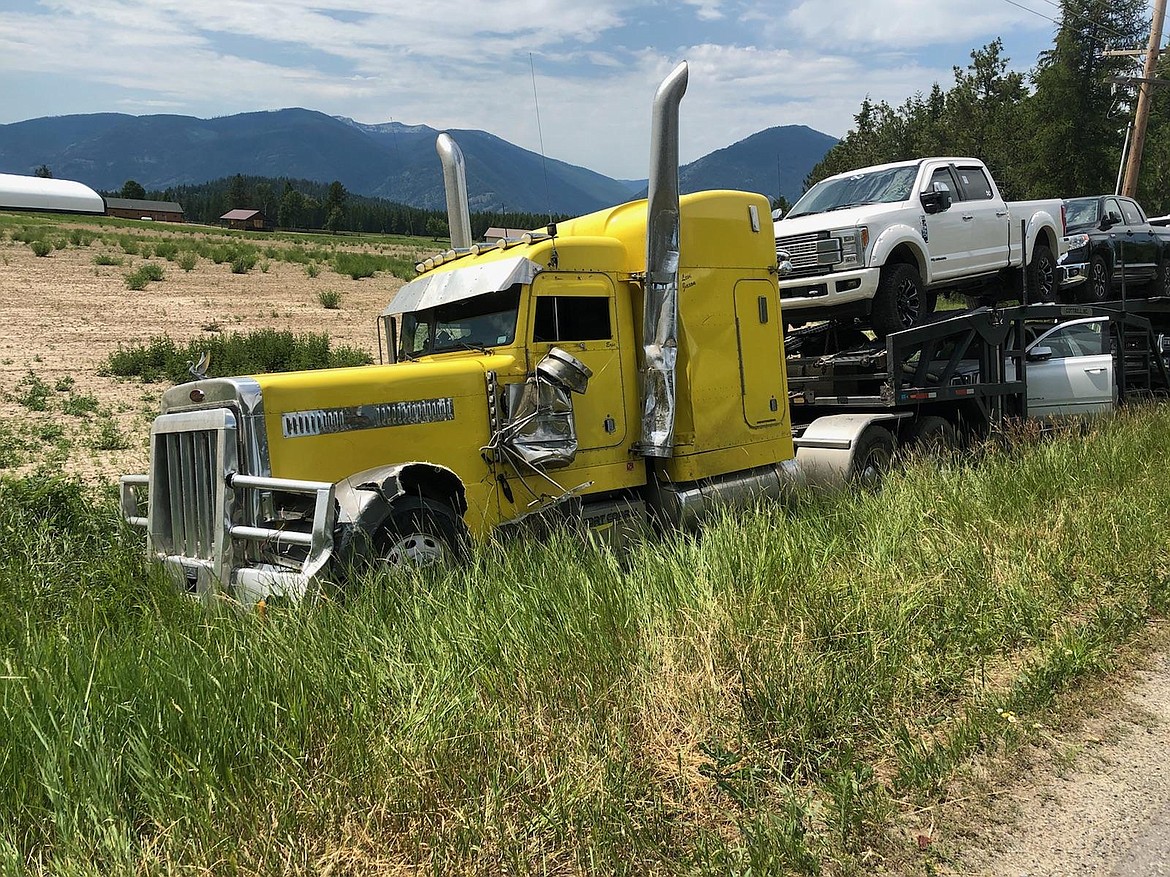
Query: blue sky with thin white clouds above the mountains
0 0 1132 178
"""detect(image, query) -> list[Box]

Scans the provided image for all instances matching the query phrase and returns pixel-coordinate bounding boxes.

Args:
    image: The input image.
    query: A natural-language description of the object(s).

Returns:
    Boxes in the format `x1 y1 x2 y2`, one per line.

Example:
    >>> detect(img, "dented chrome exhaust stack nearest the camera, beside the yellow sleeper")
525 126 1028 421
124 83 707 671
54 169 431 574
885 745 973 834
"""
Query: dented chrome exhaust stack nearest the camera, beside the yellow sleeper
638 61 687 457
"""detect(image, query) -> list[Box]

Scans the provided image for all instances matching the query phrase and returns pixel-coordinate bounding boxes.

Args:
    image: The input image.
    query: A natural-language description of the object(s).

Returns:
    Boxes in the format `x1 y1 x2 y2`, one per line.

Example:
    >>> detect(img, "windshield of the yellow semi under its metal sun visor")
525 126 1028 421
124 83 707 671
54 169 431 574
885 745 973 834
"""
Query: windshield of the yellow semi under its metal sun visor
400 283 519 359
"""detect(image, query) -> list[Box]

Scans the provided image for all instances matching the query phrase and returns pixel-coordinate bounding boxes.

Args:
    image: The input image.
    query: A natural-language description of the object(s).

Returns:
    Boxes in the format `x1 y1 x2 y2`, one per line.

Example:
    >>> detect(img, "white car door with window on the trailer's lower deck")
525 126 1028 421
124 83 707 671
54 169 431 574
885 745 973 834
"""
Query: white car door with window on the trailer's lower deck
1026 319 1116 417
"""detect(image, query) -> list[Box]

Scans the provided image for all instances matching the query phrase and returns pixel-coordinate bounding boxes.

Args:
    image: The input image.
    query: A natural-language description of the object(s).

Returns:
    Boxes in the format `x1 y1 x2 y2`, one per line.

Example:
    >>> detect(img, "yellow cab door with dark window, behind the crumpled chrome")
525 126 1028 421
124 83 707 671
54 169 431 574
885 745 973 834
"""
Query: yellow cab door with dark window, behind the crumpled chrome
528 271 633 453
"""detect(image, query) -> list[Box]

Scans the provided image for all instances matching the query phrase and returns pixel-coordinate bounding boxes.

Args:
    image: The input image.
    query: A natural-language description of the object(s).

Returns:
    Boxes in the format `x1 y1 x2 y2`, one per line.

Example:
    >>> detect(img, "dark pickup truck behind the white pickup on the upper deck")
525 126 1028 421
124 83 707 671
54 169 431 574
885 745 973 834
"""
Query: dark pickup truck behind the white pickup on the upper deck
1060 195 1170 304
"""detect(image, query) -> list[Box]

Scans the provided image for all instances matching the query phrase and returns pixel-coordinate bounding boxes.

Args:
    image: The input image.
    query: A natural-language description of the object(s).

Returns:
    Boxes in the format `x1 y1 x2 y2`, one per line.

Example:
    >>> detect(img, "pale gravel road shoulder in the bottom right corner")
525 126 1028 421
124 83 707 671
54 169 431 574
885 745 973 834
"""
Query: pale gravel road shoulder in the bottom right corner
928 626 1170 877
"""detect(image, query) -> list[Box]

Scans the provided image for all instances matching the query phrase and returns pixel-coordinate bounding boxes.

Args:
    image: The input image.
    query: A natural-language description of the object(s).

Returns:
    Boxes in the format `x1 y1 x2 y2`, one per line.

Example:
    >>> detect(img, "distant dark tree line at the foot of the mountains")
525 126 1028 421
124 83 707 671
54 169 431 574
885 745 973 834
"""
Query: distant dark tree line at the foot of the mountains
103 174 564 240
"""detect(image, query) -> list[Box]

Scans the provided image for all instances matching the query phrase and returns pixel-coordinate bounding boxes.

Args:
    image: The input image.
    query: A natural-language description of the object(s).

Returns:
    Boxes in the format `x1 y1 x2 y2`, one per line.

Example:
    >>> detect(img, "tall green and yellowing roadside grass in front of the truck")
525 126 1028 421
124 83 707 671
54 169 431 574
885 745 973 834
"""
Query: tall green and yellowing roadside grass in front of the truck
0 409 1170 875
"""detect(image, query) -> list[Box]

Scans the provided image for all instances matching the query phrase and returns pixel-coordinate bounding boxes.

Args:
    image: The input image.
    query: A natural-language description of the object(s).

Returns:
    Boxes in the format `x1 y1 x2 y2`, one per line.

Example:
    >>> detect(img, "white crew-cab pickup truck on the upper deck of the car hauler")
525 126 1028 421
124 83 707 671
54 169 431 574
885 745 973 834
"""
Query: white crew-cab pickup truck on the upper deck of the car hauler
776 158 1065 338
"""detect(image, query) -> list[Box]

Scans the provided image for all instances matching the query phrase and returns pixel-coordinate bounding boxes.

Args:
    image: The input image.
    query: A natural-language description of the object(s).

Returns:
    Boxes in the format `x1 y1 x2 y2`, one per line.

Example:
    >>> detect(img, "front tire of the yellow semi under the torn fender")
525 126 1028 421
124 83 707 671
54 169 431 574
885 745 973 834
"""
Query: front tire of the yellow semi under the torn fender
373 497 470 569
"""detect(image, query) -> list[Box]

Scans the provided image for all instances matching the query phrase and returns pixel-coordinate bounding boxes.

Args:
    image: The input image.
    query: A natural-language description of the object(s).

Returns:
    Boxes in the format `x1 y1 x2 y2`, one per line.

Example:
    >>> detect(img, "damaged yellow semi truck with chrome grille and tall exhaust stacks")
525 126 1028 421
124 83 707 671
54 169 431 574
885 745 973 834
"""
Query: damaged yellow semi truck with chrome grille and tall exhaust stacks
122 64 1170 602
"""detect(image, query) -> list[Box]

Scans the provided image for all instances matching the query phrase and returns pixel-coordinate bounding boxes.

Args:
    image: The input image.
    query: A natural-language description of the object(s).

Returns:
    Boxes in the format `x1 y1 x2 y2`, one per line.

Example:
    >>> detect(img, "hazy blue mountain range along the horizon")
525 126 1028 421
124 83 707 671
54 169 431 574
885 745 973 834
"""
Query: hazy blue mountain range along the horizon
0 109 837 215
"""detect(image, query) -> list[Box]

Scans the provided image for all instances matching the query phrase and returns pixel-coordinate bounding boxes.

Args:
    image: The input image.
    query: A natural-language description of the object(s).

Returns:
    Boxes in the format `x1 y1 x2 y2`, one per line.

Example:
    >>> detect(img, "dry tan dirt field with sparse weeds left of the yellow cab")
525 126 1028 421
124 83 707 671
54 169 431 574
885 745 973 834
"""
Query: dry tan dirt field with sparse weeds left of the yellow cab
0 222 421 483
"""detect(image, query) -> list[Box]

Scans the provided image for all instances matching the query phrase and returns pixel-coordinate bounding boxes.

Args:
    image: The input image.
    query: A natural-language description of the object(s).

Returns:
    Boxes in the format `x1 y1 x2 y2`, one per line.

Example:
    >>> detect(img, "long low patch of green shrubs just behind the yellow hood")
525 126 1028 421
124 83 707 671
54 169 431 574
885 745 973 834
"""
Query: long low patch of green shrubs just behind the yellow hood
103 329 373 382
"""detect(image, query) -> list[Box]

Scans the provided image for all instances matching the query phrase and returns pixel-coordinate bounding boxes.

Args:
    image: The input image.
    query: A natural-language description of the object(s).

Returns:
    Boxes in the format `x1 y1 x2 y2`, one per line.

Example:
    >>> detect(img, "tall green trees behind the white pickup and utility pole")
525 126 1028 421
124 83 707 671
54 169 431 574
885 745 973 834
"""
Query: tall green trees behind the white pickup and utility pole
805 0 1170 215
